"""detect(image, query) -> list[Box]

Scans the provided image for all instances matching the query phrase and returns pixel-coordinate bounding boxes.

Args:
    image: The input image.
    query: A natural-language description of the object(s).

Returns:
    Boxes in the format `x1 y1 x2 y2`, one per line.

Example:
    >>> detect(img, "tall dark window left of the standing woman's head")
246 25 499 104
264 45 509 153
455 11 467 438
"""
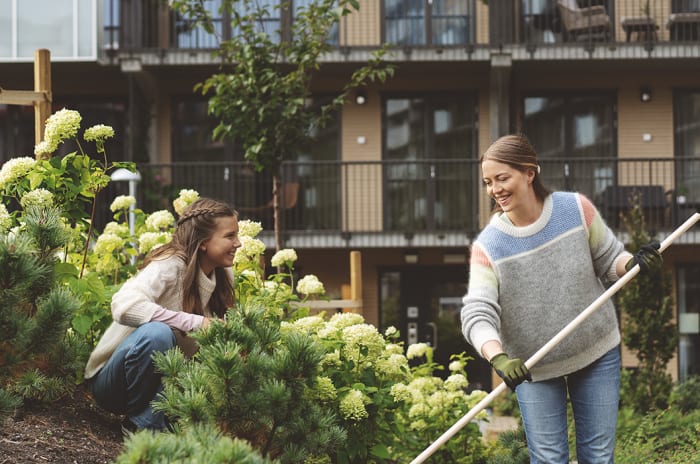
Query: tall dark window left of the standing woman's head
382 95 478 231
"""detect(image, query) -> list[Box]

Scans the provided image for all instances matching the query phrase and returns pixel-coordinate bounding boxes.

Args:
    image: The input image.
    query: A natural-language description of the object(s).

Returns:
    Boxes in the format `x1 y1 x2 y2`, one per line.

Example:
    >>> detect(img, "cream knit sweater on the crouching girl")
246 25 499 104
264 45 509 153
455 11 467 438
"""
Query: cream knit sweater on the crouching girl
85 256 228 379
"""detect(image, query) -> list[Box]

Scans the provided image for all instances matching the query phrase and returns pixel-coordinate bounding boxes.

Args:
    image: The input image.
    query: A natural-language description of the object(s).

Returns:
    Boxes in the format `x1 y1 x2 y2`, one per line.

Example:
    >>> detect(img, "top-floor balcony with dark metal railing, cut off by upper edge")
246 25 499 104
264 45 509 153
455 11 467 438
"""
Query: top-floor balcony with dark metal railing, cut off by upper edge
103 0 700 57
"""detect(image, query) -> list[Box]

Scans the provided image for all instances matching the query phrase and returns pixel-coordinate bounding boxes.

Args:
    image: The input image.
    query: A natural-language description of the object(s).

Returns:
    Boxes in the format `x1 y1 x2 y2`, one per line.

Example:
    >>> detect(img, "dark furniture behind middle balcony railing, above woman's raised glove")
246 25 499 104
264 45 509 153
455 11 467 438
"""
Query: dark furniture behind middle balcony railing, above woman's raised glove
601 185 668 228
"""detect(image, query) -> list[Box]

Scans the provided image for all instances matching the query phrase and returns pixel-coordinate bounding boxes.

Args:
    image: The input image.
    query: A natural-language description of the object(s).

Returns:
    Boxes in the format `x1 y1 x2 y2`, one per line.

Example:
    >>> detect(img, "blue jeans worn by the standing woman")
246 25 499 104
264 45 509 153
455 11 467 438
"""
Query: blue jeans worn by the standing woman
515 347 621 464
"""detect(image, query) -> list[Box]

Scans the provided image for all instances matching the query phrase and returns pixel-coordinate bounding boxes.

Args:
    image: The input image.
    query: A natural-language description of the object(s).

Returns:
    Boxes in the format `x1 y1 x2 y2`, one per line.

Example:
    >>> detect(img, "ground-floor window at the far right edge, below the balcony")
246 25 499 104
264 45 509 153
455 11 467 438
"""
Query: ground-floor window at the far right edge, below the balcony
677 264 700 382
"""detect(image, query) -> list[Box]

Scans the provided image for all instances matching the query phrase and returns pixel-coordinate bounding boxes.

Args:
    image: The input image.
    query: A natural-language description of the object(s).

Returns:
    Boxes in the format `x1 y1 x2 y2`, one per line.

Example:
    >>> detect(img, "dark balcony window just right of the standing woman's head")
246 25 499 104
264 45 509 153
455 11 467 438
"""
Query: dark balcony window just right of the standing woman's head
522 95 617 200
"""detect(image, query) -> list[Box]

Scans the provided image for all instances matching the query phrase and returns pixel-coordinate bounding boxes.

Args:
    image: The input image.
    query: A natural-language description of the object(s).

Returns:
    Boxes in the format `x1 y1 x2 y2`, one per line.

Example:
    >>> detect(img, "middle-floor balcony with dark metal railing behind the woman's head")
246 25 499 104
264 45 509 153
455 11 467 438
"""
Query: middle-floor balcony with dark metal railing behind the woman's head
97 157 700 248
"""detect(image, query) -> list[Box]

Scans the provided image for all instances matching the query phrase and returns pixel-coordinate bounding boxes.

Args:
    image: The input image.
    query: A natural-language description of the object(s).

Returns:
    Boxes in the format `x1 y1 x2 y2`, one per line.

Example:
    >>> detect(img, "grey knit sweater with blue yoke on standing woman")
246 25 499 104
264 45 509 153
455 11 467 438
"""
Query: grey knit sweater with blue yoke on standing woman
461 192 629 381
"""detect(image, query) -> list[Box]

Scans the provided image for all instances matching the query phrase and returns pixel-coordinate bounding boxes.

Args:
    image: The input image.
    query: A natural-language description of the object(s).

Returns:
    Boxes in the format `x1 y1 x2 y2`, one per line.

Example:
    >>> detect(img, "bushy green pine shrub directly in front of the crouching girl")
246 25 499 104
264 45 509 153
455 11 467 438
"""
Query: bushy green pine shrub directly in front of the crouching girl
156 305 345 463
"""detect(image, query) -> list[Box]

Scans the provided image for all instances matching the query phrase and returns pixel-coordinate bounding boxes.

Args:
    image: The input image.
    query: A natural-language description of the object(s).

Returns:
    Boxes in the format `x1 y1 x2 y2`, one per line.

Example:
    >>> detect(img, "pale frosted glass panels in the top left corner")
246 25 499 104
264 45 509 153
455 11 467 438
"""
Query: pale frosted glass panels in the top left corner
0 0 97 60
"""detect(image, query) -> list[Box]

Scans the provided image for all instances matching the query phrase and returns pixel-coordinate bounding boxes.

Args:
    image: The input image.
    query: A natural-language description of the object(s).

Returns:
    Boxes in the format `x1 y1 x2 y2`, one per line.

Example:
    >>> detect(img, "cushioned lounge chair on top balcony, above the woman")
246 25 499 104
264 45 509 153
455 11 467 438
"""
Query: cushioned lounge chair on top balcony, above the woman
557 0 611 41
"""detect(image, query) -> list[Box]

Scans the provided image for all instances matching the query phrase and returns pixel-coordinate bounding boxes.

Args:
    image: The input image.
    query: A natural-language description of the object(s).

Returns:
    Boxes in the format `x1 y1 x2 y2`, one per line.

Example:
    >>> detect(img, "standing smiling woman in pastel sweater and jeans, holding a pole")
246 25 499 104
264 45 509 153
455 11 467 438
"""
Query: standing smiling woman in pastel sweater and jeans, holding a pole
461 135 661 464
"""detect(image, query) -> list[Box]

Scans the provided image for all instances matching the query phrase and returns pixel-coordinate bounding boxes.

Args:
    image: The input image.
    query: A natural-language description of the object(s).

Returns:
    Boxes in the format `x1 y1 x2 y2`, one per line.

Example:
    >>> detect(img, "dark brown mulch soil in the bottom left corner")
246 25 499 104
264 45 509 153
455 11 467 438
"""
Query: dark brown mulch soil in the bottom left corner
0 387 123 464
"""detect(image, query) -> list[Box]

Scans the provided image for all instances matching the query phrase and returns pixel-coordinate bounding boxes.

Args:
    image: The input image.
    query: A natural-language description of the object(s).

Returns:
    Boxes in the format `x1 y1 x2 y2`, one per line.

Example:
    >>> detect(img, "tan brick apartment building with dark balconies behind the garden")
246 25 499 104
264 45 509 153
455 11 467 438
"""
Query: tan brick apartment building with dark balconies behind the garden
0 0 700 387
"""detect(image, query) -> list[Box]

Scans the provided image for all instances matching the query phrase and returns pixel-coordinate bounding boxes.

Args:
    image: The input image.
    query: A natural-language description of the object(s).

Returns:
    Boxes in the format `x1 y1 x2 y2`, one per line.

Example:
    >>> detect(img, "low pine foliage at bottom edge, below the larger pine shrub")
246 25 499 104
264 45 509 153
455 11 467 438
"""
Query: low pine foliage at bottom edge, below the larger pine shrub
116 424 272 464
